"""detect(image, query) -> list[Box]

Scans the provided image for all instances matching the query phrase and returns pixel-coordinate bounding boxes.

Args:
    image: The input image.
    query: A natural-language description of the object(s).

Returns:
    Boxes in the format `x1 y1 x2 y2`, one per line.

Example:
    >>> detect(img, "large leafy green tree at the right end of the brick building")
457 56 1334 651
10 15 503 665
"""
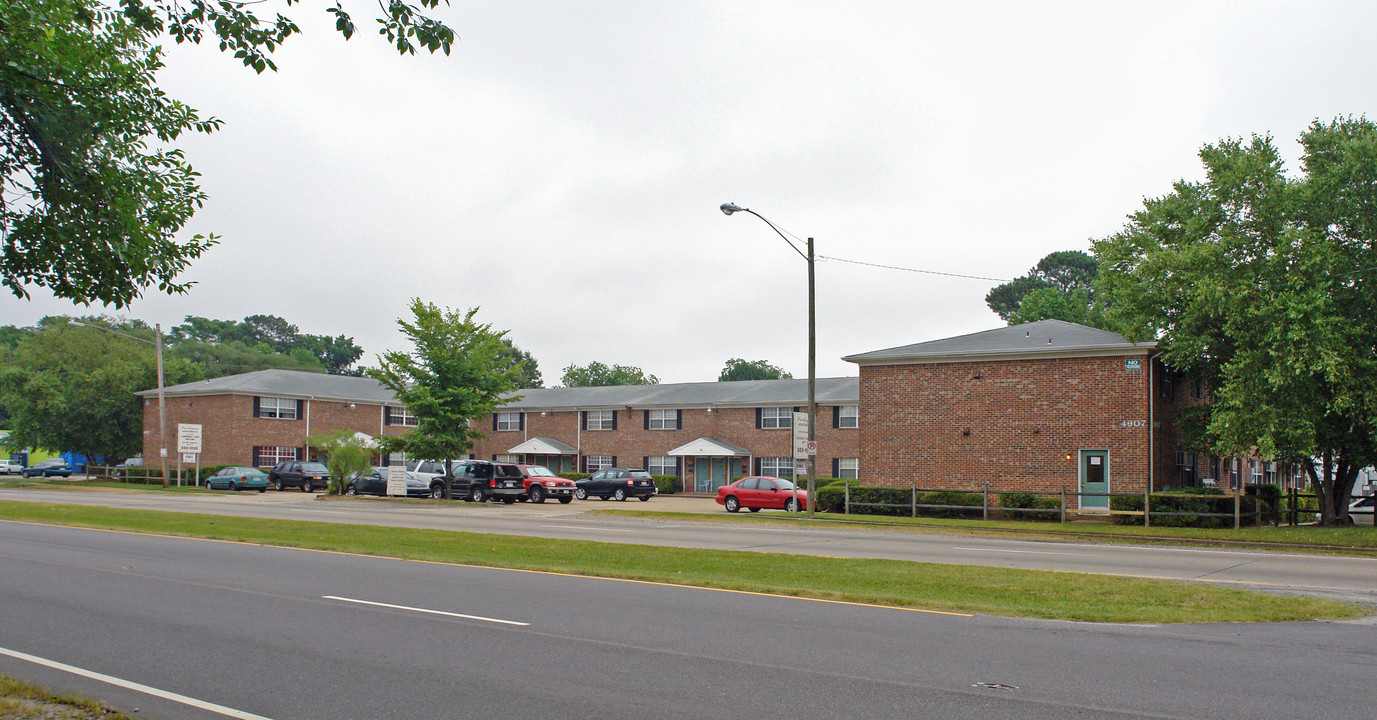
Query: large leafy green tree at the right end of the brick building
1095 118 1377 522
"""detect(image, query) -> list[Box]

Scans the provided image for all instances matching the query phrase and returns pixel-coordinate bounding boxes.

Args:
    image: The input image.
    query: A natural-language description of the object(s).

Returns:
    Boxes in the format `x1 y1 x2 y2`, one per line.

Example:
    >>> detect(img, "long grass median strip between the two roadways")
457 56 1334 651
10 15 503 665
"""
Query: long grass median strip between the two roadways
0 501 1369 624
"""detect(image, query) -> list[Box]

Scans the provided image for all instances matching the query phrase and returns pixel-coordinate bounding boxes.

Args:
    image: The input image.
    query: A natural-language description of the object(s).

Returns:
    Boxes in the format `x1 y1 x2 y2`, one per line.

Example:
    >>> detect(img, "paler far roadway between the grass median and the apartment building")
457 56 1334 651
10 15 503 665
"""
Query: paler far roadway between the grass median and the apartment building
0 489 1377 607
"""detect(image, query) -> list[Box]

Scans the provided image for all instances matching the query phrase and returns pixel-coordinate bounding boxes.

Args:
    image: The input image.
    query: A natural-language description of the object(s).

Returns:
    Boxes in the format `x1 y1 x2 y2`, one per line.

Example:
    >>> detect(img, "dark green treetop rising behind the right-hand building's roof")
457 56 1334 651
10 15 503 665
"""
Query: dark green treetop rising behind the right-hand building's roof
985 251 1104 328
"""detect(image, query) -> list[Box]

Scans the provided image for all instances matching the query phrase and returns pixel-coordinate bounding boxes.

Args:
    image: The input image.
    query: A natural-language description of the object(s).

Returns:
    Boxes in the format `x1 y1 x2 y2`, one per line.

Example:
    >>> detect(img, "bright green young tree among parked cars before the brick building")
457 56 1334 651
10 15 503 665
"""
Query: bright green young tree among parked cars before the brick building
368 299 521 497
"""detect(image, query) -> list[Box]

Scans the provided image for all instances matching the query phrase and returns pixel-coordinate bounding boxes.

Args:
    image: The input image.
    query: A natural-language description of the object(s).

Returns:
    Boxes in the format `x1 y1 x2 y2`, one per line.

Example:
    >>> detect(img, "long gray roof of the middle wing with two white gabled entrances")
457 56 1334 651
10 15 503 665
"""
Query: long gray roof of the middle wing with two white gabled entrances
503 377 861 410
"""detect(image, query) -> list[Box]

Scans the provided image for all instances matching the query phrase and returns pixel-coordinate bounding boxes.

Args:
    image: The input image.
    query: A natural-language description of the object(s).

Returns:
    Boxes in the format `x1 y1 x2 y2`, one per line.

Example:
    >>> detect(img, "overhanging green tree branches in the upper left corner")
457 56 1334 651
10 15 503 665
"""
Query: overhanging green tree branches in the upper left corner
0 0 454 307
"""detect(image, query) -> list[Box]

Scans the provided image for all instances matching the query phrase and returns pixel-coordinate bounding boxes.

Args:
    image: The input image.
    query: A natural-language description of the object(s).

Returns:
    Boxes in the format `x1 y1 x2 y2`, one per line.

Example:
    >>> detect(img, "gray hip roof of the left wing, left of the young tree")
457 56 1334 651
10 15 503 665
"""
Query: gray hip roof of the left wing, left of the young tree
135 370 397 405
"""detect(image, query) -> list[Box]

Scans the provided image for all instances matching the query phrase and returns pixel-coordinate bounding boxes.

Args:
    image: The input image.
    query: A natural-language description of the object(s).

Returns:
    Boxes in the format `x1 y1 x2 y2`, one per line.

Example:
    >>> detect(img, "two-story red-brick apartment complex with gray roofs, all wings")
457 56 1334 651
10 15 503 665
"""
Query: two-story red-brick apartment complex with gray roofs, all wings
139 321 1261 501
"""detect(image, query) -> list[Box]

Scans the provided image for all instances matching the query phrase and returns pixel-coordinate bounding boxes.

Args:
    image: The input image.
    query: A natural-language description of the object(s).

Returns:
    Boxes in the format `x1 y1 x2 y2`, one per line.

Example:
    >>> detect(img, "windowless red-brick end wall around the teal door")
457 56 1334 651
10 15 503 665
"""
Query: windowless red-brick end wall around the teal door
859 357 1151 501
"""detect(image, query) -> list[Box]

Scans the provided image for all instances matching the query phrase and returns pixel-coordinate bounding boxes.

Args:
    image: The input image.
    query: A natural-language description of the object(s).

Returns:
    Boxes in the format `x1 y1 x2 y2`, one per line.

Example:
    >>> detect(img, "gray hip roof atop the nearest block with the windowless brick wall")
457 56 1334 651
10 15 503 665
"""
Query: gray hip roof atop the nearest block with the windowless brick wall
841 319 1157 365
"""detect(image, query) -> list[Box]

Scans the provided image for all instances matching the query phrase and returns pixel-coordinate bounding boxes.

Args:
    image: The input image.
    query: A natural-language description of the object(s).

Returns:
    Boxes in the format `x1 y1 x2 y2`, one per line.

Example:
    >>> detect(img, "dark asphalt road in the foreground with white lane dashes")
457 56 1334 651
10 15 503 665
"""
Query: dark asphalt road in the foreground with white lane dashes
0 522 1377 720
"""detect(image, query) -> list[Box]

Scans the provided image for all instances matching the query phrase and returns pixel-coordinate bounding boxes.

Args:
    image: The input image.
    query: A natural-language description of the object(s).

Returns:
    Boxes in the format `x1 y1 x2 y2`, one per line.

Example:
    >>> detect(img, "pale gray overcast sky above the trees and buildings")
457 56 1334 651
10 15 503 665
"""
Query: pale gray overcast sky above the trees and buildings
0 0 1377 385
